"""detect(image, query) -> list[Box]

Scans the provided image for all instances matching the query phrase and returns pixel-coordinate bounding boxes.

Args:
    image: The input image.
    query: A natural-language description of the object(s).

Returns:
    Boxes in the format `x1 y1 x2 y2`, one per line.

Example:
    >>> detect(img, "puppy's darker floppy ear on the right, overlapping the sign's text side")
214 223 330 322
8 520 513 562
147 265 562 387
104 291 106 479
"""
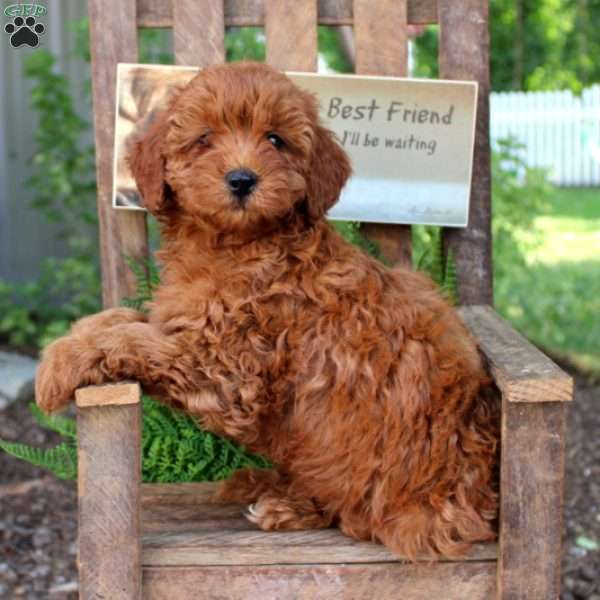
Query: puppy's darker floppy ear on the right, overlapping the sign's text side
306 125 352 221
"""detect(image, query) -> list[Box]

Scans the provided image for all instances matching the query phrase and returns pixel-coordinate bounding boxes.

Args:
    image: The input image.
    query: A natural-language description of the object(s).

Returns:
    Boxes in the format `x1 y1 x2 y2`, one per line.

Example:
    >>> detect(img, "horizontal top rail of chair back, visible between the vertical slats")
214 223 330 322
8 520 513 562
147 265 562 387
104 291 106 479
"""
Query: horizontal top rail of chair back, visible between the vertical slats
137 0 437 27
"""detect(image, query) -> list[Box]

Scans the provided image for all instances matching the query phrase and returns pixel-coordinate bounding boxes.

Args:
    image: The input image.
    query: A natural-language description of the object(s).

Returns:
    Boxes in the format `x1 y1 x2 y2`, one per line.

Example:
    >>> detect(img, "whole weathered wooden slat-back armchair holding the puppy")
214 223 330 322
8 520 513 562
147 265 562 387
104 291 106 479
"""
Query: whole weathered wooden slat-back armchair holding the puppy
76 0 572 600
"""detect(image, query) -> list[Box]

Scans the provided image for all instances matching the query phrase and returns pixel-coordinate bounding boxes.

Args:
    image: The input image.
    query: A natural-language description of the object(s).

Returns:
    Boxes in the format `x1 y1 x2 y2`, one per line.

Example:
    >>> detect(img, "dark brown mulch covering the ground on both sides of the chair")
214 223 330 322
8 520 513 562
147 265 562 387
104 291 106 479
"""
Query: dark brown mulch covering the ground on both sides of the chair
0 368 600 600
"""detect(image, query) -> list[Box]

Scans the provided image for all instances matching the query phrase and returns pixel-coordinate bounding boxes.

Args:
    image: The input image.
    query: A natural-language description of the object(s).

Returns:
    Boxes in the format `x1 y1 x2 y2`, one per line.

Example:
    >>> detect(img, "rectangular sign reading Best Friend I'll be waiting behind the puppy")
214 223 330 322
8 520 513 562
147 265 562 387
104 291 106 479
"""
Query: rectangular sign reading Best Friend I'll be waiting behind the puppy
113 64 477 227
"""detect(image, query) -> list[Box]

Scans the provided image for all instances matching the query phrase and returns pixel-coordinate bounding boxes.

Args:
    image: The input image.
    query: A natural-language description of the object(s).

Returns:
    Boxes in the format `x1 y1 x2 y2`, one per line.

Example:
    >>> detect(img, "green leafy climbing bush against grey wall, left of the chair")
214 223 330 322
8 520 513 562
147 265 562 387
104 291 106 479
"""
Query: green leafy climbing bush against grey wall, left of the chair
0 50 100 348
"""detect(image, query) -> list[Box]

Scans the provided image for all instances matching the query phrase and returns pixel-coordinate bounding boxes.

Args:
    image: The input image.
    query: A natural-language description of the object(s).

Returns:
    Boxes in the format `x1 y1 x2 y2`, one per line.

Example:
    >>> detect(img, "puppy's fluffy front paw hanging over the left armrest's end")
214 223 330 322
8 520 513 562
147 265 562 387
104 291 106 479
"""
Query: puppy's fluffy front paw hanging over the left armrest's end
35 335 101 412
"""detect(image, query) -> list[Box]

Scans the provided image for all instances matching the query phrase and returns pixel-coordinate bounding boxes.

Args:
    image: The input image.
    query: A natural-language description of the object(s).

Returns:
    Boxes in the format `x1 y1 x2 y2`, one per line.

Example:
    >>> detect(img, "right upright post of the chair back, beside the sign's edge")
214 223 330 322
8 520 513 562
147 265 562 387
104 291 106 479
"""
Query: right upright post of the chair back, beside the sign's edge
438 0 493 304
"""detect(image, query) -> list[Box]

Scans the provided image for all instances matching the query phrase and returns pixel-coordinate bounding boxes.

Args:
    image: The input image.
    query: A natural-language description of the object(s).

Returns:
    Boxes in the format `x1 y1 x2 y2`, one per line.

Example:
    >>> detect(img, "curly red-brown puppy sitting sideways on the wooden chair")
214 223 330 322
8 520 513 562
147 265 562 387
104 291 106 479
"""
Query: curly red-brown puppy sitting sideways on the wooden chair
37 63 497 558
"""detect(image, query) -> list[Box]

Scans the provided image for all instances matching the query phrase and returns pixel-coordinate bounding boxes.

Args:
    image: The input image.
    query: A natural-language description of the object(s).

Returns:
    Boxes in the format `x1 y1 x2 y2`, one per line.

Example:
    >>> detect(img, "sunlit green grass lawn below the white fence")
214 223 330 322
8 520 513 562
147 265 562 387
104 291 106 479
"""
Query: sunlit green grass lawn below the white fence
498 188 600 374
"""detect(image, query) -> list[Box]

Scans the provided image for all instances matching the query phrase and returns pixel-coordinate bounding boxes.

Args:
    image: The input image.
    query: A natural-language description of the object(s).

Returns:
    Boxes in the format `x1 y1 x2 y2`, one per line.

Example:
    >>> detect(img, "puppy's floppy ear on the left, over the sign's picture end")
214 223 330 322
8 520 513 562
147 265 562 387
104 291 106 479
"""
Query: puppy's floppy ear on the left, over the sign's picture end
127 111 173 214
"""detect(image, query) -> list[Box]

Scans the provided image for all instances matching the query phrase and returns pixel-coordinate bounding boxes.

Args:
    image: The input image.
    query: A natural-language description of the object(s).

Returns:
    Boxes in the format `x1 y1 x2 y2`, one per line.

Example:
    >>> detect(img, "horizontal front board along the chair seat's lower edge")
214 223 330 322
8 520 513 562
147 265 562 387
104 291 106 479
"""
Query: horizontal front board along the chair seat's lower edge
144 563 496 600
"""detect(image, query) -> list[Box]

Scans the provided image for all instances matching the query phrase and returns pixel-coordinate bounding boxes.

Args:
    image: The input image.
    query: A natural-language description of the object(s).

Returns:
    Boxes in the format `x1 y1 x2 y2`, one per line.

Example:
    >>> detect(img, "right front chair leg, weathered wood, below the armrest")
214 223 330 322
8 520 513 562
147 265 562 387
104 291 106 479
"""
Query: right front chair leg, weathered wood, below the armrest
497 399 567 600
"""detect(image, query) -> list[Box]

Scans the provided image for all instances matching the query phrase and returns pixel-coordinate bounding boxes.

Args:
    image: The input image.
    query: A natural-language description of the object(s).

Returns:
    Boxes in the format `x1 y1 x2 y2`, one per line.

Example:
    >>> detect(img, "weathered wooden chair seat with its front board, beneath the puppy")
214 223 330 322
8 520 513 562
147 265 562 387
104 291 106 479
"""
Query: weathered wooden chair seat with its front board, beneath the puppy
142 483 497 600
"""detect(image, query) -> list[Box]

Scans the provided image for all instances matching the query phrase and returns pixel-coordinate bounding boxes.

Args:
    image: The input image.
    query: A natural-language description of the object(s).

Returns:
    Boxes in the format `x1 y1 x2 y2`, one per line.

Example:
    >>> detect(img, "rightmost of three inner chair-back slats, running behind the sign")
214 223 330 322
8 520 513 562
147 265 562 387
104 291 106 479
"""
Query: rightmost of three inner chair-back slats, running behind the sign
353 0 412 266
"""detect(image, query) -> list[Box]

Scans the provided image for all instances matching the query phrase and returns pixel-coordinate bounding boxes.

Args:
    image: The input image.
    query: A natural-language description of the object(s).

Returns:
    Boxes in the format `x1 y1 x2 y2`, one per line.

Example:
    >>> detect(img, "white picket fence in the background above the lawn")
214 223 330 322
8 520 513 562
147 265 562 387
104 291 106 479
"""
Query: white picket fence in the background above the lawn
491 85 600 186
